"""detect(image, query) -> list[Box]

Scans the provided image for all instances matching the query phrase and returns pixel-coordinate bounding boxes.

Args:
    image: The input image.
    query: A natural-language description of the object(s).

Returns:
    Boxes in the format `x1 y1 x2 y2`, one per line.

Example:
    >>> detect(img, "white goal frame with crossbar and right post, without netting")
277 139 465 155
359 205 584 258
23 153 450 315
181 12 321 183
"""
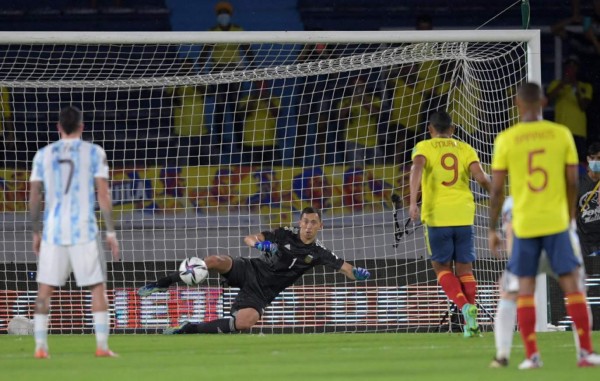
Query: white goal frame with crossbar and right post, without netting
0 30 548 331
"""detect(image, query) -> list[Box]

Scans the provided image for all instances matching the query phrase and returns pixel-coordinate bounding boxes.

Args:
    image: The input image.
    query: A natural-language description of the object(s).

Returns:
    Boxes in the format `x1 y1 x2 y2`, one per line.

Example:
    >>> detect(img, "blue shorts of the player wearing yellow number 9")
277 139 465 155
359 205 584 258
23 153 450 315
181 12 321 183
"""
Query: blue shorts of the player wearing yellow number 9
424 225 477 263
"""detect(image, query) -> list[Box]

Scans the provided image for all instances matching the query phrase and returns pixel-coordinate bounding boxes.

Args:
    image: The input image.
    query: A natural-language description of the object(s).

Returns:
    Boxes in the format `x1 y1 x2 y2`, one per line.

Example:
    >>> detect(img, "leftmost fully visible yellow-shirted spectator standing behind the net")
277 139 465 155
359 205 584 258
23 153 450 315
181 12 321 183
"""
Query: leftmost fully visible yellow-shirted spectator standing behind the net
167 61 218 165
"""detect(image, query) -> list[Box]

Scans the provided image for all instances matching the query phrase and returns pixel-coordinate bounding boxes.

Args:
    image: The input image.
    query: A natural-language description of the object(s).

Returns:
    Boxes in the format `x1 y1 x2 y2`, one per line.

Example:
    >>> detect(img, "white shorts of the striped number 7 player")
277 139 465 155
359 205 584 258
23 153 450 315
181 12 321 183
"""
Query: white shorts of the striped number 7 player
37 240 106 287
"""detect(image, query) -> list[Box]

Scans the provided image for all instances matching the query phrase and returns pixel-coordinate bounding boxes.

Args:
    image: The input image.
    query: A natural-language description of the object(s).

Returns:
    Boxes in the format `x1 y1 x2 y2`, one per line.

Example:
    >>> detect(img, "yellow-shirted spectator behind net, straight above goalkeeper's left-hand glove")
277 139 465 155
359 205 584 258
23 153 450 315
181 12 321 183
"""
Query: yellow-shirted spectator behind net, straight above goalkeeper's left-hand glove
239 81 281 166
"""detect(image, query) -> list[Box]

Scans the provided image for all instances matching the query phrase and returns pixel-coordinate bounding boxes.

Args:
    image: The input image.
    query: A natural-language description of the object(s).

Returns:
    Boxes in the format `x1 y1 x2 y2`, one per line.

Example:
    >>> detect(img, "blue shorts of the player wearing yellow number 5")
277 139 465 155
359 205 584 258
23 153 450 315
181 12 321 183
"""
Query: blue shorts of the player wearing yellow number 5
507 230 581 277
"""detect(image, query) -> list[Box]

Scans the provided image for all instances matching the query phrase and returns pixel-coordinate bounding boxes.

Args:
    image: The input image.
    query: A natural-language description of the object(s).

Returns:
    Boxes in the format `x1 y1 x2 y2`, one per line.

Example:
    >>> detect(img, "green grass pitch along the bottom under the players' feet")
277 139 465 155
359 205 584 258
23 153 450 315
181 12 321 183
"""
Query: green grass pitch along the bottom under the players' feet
0 332 600 381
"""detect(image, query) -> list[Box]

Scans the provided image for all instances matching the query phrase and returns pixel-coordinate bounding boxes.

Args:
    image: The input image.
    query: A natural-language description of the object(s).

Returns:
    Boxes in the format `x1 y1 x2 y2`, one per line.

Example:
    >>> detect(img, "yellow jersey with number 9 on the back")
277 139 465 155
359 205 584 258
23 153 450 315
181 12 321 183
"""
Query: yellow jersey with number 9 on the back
412 138 479 226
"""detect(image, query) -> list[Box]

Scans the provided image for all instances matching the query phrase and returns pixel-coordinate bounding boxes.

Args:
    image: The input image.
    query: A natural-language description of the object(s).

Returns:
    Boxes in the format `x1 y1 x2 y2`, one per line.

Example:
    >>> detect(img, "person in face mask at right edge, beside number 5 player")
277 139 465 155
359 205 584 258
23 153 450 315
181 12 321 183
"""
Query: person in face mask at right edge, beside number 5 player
577 142 600 256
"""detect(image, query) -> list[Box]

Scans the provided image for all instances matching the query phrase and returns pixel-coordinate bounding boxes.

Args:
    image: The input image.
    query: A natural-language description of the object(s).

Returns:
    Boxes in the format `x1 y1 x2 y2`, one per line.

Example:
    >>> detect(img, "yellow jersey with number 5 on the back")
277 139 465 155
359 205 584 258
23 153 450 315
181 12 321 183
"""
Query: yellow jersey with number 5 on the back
492 120 578 238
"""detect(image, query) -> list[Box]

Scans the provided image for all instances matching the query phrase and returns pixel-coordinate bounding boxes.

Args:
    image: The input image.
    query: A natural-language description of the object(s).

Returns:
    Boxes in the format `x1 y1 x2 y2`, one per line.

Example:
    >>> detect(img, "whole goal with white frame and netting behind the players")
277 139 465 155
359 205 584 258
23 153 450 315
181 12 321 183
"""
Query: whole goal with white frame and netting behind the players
0 30 546 333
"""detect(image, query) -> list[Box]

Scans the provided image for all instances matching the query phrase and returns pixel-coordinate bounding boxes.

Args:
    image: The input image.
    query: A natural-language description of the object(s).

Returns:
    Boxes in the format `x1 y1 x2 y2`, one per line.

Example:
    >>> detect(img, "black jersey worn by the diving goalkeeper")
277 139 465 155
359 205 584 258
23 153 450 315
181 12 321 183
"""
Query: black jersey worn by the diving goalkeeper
253 227 344 299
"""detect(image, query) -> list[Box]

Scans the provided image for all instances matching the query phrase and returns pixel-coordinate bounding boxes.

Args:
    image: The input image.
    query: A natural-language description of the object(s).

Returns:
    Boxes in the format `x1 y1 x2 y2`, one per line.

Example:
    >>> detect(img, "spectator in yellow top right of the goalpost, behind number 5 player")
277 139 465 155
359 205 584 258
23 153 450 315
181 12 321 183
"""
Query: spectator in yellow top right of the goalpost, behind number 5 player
548 56 592 162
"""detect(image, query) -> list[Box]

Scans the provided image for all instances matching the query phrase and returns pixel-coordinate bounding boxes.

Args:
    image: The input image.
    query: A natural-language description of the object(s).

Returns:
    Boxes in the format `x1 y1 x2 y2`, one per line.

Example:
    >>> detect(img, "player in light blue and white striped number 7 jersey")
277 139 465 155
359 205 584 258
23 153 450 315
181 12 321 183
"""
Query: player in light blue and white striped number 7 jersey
29 106 119 359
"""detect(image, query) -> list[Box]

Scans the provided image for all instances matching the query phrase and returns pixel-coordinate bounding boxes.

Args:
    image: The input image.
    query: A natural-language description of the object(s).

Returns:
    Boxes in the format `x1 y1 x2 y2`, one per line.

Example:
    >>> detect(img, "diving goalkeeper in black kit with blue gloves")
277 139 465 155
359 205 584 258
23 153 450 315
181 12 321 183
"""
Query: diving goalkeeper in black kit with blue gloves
138 207 370 335
